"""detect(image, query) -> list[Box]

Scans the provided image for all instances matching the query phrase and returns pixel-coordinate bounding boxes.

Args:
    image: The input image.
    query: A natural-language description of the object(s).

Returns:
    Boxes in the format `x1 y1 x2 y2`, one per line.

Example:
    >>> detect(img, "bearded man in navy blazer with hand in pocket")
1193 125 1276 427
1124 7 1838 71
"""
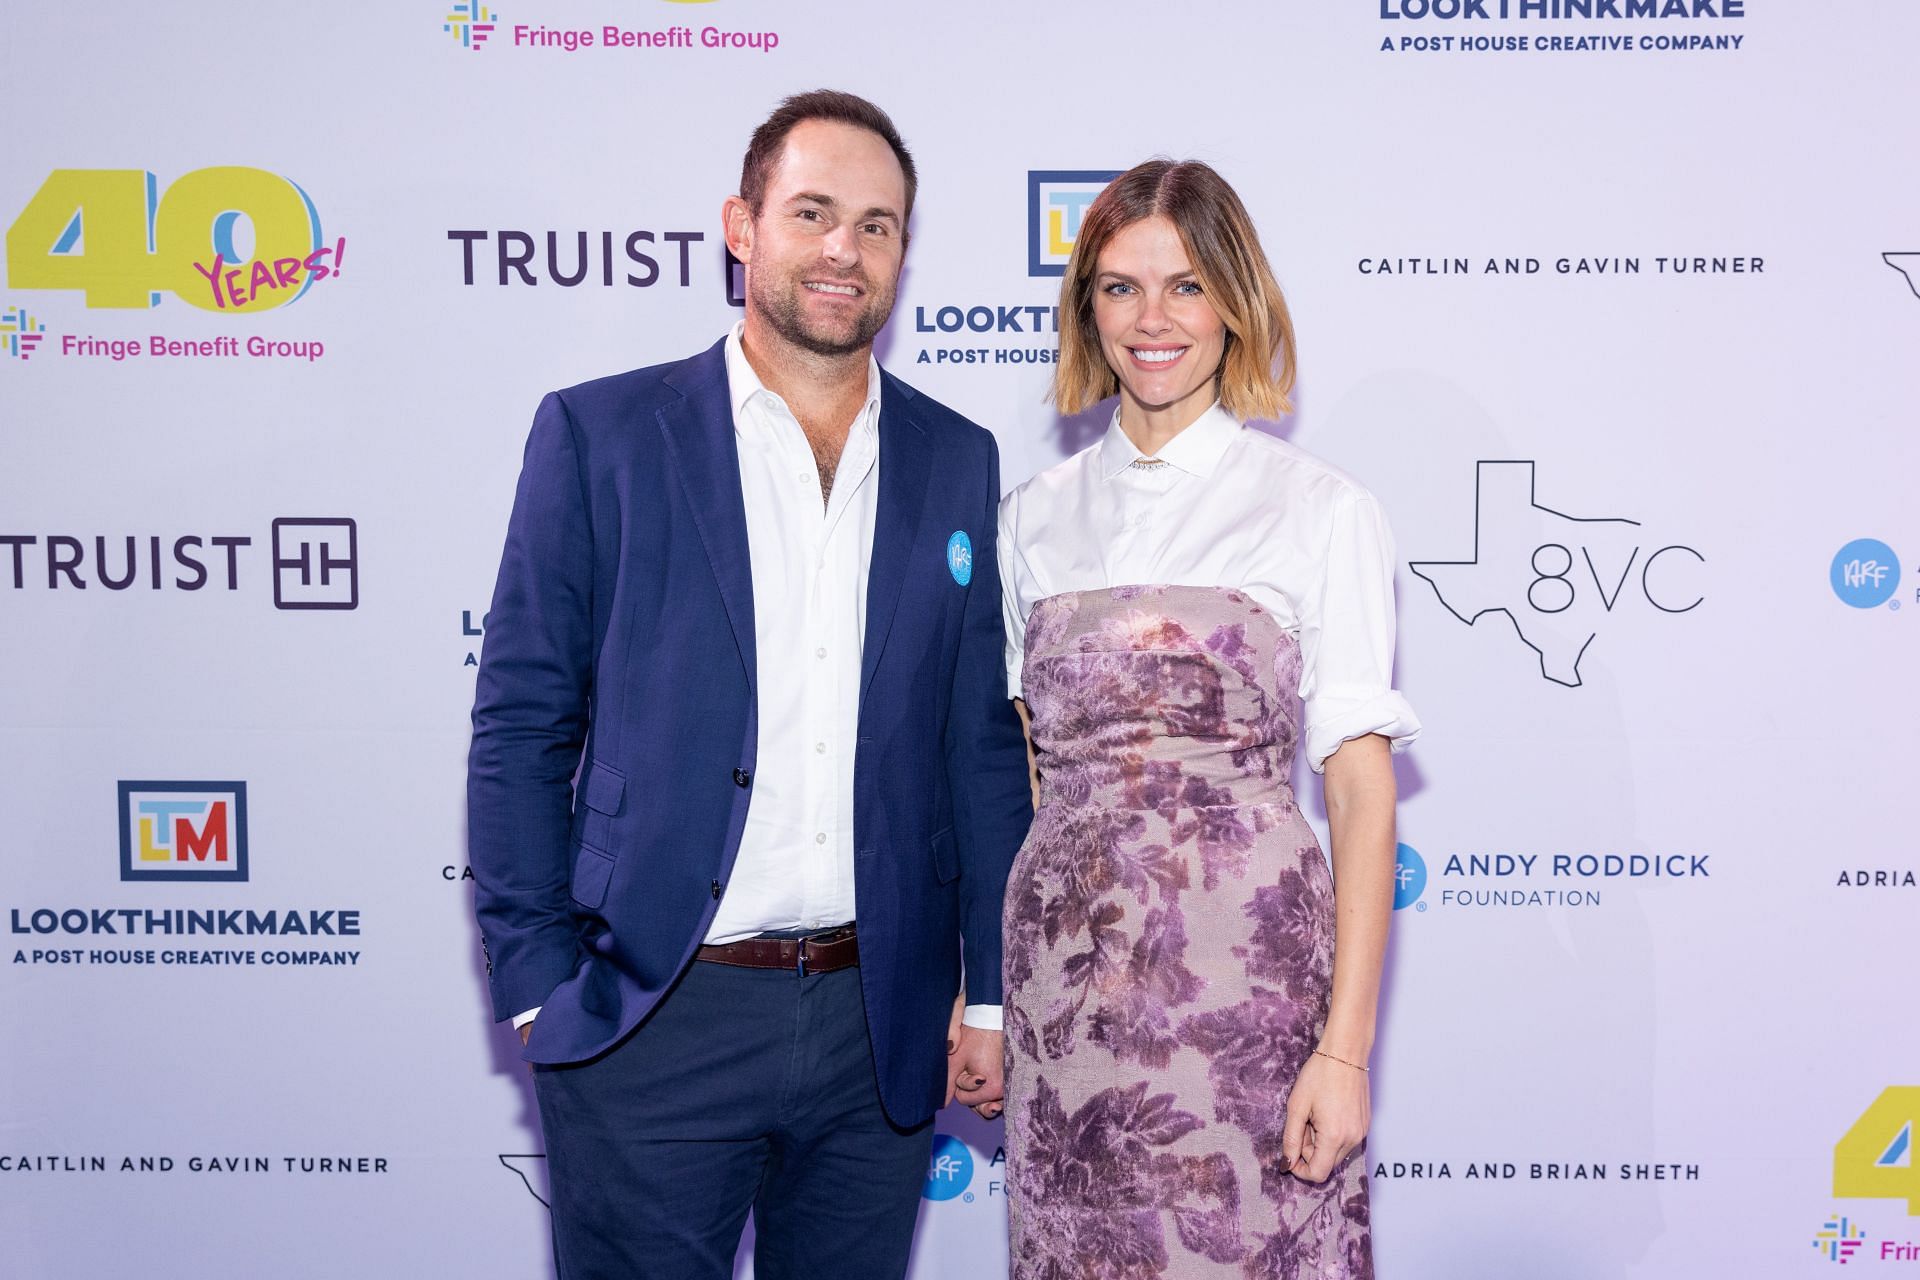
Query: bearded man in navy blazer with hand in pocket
468 90 1031 1280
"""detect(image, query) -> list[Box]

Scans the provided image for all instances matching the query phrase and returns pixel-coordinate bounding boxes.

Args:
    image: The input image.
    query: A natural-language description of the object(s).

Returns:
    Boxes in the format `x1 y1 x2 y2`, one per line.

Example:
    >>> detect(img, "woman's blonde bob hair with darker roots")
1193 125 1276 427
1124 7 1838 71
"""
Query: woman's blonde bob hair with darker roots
1054 159 1294 422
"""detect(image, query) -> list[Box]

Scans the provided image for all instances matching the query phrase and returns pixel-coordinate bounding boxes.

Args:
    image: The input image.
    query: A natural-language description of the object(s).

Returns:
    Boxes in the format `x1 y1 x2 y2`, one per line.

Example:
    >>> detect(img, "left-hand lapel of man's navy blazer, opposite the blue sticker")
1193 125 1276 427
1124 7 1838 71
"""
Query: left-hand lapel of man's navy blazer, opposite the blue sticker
659 340 758 695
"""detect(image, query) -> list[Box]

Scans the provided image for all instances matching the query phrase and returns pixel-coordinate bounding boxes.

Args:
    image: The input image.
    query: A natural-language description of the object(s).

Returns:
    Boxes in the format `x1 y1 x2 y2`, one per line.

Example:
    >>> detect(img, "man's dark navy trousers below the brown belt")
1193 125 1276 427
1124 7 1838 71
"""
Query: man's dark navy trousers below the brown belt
536 961 933 1280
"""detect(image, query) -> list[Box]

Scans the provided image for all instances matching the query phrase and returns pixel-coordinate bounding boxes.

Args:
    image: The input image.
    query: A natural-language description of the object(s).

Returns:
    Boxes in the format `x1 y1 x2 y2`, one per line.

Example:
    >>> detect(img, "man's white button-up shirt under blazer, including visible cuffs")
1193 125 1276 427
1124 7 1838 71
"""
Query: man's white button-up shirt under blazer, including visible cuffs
513 324 1000 1029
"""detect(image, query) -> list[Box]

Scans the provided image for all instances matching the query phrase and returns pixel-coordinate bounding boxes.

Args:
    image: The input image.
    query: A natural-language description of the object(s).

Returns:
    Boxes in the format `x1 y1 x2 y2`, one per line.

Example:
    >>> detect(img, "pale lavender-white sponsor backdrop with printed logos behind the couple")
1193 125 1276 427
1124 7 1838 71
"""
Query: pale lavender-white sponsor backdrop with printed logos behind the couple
0 0 1920 1280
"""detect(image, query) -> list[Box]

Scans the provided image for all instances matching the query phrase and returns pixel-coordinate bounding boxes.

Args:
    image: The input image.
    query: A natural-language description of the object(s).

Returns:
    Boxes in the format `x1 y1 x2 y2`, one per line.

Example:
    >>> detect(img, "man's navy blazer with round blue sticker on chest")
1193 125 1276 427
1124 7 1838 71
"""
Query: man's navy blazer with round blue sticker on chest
467 335 1031 1125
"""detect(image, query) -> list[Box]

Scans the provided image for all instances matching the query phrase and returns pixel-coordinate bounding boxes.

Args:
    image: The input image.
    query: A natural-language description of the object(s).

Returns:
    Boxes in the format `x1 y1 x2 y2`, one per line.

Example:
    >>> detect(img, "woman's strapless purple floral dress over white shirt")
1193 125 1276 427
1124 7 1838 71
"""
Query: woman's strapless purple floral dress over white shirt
1006 585 1373 1280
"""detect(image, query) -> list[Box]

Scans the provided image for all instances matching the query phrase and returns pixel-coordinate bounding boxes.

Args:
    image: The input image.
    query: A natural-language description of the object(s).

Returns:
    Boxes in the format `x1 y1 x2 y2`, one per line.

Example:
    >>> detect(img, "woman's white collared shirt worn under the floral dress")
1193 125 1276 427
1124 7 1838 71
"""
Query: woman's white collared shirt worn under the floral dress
1000 405 1421 773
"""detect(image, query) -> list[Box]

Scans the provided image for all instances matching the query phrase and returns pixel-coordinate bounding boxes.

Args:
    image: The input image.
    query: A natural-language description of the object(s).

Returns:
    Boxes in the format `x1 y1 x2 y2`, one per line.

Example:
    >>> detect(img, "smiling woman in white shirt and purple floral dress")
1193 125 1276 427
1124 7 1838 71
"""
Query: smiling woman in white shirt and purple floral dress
1000 161 1419 1280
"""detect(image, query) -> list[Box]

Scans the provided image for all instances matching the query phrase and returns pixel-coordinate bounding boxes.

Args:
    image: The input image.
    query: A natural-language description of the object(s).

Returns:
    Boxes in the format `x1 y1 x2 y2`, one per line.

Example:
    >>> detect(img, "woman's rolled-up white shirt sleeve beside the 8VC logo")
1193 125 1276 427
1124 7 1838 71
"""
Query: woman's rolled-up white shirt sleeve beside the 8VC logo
1300 487 1421 773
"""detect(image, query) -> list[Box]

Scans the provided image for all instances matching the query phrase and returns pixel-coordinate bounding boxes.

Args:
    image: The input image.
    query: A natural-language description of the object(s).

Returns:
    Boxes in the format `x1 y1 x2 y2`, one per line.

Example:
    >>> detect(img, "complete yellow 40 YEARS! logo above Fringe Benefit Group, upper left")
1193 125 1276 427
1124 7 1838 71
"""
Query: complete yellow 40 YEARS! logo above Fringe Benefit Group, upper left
6 165 348 313
